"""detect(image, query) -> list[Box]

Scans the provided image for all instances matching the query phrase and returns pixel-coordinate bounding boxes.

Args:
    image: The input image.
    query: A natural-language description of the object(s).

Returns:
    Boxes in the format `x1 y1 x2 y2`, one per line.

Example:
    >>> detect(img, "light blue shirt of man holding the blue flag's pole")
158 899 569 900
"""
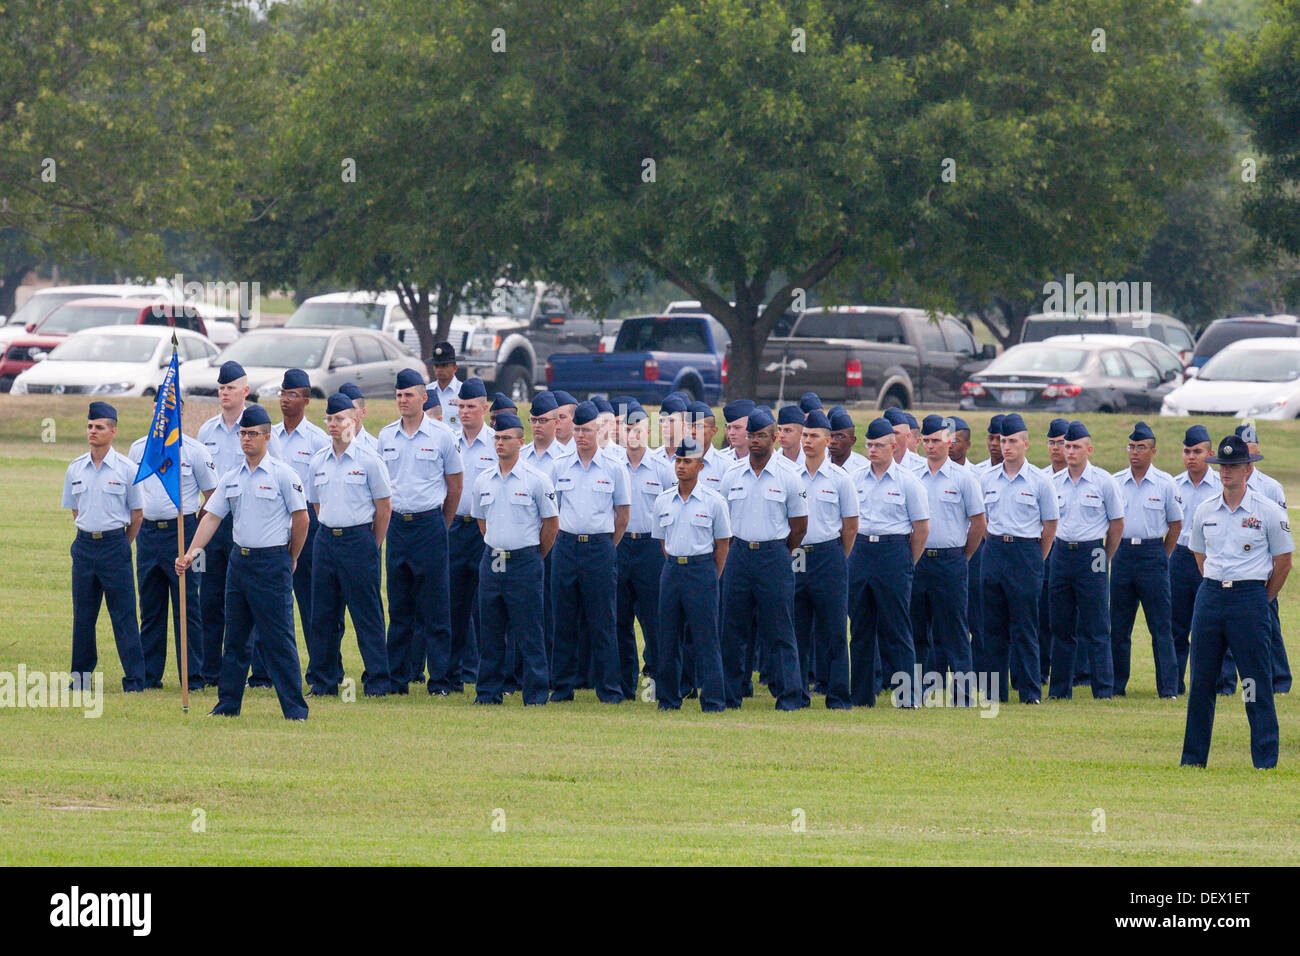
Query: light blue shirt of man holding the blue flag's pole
207 454 307 548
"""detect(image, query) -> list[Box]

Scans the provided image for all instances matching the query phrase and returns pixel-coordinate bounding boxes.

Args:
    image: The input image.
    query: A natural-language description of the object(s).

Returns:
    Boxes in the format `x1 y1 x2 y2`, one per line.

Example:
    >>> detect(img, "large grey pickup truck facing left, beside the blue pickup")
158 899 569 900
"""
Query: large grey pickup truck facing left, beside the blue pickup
450 281 619 402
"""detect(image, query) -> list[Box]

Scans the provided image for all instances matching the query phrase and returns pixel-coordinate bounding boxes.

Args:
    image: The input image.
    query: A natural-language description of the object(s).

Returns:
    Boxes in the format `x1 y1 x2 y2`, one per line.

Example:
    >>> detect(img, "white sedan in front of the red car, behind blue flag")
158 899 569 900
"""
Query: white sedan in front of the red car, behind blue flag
13 325 217 395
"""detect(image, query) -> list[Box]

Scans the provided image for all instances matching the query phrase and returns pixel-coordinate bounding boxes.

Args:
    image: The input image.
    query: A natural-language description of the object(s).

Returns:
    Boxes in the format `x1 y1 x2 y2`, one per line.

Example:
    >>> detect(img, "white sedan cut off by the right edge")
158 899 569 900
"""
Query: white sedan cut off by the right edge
1160 337 1300 419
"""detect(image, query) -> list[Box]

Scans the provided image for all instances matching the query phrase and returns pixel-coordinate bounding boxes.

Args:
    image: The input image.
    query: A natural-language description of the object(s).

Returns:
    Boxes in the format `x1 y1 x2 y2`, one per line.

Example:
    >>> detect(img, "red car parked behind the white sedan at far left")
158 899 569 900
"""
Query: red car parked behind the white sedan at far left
0 297 208 392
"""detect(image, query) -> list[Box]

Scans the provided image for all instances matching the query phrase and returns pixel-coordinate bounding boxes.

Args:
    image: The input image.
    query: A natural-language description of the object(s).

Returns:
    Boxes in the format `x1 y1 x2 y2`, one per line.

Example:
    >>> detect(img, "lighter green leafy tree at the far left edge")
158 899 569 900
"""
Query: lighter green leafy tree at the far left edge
0 0 265 312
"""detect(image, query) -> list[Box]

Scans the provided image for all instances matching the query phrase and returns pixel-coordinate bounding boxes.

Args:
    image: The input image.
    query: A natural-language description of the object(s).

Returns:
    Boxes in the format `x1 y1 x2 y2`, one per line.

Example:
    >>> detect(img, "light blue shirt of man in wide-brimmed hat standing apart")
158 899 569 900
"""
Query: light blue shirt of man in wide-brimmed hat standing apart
1188 488 1296 581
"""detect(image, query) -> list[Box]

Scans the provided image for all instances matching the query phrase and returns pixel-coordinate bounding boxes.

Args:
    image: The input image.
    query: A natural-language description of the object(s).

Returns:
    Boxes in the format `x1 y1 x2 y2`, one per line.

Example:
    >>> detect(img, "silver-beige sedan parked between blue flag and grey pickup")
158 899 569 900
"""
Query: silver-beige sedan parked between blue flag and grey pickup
181 328 424 401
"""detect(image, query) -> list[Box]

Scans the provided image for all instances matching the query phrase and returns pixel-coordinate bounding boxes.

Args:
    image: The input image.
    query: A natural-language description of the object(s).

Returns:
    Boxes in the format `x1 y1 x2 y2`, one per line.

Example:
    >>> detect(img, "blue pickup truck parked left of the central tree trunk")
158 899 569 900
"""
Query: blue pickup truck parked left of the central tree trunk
546 313 731 405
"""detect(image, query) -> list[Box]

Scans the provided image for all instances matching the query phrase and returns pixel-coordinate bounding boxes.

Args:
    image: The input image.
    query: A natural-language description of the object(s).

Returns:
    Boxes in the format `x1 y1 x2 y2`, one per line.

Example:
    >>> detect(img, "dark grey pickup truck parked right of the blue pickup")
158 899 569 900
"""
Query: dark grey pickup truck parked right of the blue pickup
755 306 996 408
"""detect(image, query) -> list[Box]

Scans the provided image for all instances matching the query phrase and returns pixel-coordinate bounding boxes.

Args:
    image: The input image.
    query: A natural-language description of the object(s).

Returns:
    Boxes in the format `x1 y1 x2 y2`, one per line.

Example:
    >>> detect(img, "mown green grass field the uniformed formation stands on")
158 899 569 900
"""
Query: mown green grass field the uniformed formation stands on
0 397 1300 865
